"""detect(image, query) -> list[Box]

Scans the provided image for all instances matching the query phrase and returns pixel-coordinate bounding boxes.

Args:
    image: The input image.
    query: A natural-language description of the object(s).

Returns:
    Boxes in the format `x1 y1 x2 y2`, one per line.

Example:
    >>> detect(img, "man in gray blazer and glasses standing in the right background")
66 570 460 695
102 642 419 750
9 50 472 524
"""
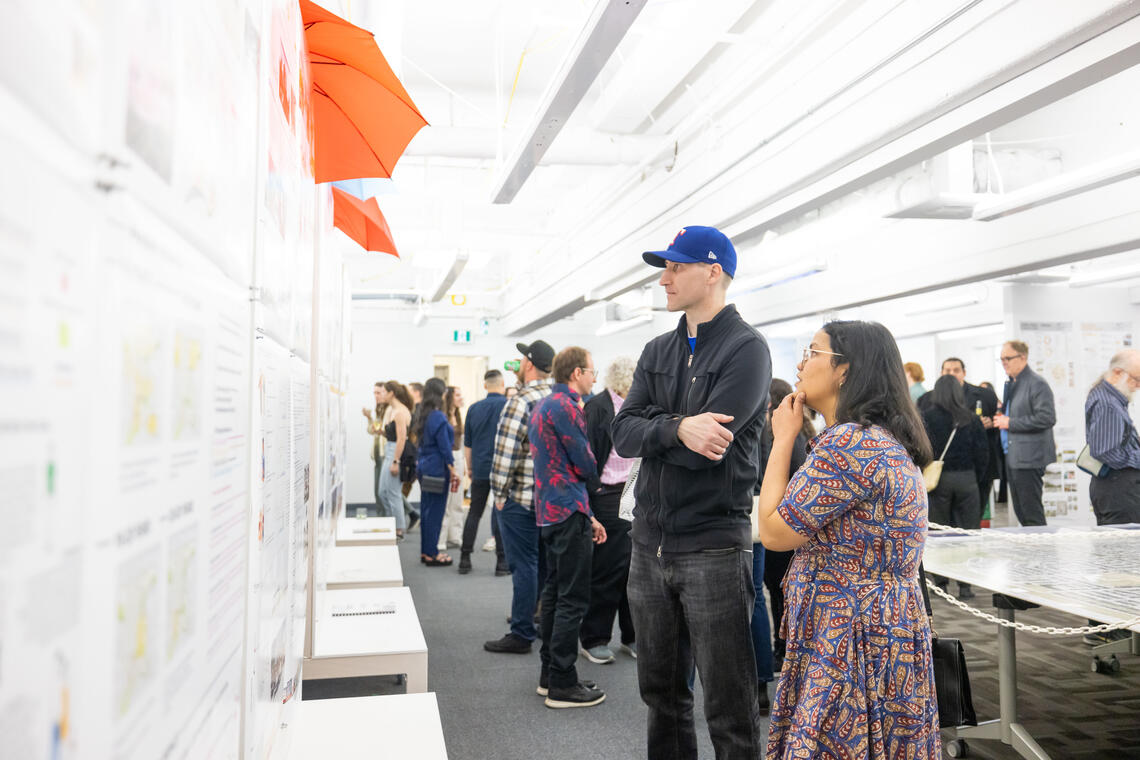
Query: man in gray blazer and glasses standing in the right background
994 341 1057 525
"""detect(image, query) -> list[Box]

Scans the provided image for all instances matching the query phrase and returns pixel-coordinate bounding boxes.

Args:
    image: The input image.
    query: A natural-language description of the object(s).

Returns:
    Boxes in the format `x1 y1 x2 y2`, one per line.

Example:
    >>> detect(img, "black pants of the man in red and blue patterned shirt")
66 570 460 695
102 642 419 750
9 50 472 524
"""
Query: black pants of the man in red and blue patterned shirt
539 512 594 688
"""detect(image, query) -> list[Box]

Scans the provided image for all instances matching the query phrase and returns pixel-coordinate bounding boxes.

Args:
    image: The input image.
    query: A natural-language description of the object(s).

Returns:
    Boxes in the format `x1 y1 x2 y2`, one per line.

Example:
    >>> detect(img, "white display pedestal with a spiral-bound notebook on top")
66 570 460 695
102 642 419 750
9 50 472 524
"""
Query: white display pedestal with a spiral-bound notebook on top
302 588 428 694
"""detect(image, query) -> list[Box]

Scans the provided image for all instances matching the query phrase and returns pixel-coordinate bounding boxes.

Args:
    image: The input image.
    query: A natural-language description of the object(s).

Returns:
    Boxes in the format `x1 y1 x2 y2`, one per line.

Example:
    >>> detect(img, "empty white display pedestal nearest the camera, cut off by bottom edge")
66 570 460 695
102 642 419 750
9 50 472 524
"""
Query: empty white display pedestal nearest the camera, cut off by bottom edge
290 694 447 760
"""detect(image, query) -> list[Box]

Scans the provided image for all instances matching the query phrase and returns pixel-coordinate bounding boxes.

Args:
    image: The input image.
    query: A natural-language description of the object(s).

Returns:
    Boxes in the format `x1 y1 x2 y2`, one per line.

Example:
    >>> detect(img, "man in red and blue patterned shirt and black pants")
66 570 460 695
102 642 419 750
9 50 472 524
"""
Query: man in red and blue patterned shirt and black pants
528 346 605 708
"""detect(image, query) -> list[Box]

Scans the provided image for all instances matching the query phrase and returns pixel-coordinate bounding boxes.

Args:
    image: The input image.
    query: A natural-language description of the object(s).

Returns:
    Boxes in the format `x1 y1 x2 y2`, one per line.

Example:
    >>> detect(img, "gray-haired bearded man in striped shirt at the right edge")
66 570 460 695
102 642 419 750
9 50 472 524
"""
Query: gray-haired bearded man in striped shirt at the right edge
1084 349 1140 525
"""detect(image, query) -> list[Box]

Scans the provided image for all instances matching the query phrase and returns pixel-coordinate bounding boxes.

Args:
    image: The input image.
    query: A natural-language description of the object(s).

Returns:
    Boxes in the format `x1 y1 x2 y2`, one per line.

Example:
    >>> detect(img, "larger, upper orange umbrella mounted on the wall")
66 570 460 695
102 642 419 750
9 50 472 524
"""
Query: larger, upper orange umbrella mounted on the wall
300 0 428 182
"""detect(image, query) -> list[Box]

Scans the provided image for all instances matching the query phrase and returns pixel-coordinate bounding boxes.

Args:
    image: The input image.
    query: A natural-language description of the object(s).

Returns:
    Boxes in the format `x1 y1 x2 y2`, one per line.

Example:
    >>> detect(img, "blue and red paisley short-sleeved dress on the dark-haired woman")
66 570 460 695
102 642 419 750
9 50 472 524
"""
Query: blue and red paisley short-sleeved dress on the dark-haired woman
767 423 942 760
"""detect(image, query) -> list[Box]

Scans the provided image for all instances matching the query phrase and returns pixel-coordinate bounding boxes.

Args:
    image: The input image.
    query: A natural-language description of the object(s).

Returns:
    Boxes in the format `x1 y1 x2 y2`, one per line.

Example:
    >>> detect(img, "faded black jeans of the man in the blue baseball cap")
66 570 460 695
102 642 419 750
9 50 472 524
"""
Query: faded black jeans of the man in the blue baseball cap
628 544 765 760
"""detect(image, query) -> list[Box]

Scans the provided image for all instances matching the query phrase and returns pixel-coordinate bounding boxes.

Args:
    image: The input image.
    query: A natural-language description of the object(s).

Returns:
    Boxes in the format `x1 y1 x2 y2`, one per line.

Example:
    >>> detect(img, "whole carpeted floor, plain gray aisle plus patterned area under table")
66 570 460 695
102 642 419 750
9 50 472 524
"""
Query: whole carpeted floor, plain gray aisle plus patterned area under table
302 505 1140 760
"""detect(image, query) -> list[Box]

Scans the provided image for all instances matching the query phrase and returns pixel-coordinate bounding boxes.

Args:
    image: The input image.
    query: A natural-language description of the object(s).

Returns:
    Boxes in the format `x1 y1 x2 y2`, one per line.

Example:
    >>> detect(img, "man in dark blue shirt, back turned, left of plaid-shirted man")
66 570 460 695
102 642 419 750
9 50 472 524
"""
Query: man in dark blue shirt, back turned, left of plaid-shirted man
459 369 511 575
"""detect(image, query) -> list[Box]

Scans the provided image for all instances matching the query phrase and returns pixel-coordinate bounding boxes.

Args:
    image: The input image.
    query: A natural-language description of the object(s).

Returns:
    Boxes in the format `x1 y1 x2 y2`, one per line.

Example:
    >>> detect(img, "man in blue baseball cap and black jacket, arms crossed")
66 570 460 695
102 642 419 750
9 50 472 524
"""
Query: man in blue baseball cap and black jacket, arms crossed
612 227 772 760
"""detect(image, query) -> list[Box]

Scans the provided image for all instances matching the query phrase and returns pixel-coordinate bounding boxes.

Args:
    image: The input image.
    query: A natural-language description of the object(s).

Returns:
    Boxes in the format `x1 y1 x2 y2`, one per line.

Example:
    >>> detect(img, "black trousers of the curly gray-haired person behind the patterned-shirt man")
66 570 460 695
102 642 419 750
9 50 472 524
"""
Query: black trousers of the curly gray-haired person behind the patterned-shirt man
581 485 636 649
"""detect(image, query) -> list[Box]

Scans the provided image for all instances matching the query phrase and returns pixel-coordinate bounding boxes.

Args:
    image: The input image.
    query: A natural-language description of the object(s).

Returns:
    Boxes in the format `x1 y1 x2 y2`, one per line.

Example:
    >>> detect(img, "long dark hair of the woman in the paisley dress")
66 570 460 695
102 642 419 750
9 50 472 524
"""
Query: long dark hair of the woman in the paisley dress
823 320 934 467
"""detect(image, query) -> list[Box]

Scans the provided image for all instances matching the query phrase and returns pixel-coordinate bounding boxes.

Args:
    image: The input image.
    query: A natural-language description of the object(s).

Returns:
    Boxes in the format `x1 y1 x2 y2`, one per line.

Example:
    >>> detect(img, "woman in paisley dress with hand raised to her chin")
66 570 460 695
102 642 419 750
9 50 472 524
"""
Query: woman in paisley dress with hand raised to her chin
757 321 942 760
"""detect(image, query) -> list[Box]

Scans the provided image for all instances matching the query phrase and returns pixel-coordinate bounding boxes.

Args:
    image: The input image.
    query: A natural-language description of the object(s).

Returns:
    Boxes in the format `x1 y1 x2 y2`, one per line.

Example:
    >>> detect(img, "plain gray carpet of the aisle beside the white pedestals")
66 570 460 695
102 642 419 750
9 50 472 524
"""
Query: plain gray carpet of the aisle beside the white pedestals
302 509 743 760
